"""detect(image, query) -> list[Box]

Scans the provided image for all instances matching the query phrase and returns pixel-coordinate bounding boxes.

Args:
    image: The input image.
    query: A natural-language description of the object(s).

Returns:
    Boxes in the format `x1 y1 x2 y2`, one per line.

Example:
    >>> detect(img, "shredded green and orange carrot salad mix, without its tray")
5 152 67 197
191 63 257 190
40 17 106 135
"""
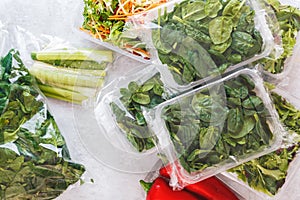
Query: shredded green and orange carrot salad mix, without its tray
82 0 166 59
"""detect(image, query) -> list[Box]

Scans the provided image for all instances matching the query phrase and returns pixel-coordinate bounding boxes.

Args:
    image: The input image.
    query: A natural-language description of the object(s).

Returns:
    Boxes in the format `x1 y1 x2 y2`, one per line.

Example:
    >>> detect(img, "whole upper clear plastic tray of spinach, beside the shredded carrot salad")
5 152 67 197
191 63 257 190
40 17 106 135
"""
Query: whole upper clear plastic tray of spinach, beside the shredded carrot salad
130 0 274 90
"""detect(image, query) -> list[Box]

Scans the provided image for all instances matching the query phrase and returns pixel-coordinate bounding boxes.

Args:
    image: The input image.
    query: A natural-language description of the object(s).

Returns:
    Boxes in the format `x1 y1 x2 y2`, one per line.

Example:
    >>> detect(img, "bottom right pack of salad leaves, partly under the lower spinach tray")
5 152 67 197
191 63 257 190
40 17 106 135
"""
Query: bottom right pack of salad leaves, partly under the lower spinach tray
218 143 300 199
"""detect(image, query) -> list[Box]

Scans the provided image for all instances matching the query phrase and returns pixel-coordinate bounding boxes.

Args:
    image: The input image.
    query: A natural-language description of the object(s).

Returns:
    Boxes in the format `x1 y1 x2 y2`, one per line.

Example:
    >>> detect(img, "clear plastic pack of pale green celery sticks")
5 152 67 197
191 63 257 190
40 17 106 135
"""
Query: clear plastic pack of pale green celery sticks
30 38 114 104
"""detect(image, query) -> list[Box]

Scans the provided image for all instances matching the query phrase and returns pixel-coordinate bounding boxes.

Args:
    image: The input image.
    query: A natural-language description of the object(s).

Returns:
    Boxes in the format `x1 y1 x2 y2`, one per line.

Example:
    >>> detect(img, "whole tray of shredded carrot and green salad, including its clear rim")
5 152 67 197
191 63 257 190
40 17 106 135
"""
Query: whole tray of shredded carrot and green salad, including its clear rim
73 0 167 63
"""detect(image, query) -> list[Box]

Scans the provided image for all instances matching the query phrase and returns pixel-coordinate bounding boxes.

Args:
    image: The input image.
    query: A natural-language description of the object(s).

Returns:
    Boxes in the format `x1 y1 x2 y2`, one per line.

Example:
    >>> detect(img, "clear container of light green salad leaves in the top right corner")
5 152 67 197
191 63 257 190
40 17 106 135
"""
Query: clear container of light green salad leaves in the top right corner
254 0 300 84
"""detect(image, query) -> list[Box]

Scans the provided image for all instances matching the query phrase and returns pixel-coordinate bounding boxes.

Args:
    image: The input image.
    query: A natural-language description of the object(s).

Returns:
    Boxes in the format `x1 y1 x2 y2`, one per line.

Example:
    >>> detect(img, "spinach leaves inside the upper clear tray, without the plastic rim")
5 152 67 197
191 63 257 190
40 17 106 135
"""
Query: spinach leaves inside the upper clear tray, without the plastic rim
152 0 263 85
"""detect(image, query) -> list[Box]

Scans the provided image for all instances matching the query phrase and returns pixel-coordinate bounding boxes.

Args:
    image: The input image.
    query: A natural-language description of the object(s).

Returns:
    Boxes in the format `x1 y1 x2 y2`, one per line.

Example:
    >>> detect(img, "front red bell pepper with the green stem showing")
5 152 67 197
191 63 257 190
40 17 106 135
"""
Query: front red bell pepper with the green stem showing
140 177 202 200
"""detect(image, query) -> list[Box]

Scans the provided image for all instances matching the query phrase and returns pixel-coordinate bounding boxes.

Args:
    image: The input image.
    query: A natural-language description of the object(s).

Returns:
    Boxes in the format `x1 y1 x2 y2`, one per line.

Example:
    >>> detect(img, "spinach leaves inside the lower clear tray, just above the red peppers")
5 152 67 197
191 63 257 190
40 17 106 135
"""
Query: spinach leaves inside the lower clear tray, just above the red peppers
162 75 274 172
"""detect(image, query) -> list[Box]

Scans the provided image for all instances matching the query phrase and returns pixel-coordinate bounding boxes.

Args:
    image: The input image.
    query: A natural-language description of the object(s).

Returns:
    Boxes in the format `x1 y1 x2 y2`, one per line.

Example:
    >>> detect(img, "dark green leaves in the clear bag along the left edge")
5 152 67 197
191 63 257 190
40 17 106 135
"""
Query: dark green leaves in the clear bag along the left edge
0 50 85 199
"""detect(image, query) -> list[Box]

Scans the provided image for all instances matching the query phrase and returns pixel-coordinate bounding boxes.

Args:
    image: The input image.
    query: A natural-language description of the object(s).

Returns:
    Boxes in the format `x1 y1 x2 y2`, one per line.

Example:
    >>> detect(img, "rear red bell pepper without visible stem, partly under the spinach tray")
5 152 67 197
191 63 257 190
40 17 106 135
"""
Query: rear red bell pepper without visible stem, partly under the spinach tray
159 163 238 200
